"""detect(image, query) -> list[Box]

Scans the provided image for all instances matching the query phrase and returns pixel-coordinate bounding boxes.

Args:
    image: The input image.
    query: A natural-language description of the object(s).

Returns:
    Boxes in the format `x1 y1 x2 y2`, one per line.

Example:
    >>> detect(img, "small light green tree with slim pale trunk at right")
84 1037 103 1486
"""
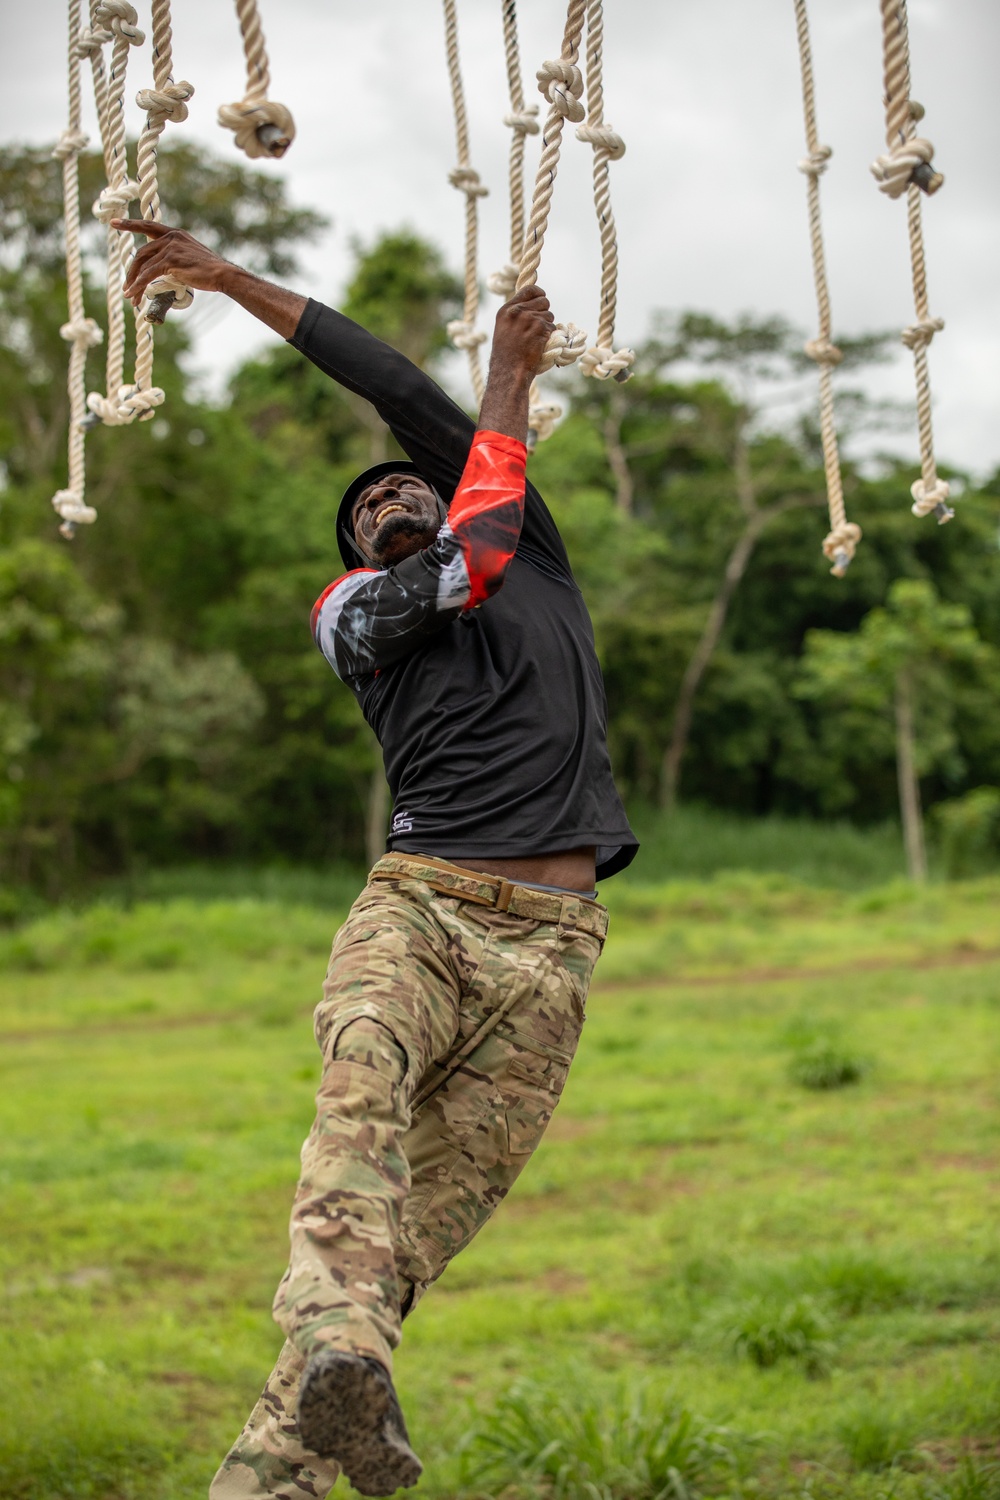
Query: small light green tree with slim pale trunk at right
798 579 1000 881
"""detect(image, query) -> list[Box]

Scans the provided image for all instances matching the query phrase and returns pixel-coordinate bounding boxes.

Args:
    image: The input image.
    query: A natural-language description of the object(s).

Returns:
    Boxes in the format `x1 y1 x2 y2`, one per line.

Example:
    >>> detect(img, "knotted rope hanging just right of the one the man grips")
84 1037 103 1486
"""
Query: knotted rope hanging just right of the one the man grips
576 0 636 381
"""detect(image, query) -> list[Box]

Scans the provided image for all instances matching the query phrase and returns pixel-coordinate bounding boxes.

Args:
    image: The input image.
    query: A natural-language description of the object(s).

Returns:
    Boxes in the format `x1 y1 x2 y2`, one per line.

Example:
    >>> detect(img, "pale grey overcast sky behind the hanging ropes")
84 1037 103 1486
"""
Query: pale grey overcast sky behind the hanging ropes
0 0 1000 474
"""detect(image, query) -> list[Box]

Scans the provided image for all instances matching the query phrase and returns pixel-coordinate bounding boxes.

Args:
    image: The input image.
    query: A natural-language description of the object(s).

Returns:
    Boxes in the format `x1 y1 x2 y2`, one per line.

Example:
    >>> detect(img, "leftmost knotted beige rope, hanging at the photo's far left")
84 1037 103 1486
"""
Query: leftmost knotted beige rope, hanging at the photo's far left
52 0 103 537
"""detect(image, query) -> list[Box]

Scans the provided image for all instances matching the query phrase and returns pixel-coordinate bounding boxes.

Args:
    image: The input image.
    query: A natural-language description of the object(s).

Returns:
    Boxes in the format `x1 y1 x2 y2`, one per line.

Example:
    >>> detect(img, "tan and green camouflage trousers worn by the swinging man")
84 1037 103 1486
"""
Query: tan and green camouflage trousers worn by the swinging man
210 855 607 1500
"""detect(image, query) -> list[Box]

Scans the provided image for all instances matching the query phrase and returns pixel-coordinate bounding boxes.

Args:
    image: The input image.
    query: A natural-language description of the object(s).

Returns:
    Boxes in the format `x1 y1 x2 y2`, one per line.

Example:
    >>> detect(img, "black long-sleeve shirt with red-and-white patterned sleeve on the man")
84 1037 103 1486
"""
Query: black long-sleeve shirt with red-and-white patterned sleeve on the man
291 302 637 879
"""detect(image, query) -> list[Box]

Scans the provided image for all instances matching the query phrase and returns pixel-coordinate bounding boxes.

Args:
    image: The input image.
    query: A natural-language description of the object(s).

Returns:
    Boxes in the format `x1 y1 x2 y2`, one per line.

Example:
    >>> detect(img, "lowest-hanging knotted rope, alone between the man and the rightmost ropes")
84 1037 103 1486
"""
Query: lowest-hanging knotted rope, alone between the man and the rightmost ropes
795 0 861 578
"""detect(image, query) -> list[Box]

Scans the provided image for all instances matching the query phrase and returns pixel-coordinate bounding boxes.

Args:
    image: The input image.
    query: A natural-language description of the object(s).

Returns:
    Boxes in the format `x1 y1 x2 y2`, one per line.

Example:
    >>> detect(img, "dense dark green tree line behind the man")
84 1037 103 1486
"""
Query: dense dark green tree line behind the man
0 146 1000 894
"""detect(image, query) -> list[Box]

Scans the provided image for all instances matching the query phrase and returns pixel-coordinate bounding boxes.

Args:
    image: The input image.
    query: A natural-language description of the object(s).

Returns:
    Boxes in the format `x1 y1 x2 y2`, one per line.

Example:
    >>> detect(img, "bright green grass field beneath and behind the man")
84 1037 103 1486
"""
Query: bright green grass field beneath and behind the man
0 855 1000 1500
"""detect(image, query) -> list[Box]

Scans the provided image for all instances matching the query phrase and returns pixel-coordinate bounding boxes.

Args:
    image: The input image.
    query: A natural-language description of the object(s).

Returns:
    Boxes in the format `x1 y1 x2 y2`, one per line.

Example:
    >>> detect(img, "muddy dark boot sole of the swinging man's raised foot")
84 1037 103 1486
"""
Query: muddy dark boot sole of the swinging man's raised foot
298 1349 423 1496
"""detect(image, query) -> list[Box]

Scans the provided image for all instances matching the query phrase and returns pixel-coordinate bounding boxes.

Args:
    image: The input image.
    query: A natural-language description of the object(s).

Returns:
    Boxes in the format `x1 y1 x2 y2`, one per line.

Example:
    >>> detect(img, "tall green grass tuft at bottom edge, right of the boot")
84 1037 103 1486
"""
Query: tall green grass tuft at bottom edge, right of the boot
466 1382 735 1500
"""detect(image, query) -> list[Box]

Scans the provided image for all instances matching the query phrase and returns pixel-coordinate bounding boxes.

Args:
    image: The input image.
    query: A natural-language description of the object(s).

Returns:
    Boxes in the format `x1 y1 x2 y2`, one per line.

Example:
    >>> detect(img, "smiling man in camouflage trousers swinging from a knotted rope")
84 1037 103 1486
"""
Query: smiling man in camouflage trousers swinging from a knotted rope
115 221 637 1500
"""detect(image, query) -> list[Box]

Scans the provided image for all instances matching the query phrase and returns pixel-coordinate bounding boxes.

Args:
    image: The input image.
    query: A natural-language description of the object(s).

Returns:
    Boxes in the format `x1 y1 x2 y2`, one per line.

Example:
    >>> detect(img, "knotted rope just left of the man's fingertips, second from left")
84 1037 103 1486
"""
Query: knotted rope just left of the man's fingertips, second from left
81 0 145 428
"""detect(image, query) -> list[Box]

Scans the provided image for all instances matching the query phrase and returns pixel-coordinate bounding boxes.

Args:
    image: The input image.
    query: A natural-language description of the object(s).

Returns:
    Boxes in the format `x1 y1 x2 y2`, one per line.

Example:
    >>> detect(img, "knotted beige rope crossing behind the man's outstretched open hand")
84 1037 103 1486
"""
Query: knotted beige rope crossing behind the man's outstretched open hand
120 0 195 422
